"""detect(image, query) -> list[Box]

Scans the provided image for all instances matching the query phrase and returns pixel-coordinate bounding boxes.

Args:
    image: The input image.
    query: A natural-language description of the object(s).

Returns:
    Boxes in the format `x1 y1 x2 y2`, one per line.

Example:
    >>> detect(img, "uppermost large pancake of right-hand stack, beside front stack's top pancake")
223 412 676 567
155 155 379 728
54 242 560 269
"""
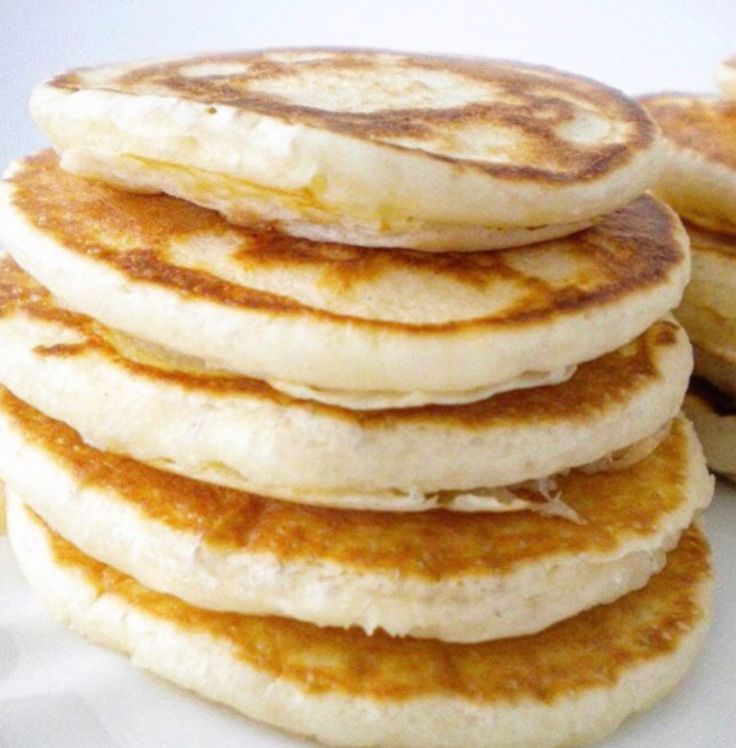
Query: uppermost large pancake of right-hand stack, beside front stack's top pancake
641 94 736 234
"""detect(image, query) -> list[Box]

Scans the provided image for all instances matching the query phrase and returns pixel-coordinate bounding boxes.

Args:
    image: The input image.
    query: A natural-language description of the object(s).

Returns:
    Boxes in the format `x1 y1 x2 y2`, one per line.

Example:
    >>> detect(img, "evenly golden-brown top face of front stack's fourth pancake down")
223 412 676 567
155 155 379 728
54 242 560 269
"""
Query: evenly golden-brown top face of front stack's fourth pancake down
0 388 689 580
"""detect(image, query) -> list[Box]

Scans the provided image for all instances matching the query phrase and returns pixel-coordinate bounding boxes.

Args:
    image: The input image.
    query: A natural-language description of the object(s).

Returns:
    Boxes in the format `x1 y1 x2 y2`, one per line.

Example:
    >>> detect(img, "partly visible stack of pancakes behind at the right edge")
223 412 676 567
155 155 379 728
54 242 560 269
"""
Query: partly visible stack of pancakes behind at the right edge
642 58 736 481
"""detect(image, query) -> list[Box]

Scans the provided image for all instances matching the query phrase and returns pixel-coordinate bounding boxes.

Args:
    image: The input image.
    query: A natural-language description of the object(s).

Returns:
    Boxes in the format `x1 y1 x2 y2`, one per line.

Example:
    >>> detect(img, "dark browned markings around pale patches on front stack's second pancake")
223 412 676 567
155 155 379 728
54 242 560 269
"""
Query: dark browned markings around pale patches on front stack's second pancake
9 151 686 336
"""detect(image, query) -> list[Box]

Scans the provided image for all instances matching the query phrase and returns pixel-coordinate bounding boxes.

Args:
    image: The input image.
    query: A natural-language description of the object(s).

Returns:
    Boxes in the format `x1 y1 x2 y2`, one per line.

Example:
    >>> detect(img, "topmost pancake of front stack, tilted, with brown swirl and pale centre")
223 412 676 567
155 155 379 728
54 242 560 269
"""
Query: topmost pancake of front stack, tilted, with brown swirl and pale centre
31 49 661 251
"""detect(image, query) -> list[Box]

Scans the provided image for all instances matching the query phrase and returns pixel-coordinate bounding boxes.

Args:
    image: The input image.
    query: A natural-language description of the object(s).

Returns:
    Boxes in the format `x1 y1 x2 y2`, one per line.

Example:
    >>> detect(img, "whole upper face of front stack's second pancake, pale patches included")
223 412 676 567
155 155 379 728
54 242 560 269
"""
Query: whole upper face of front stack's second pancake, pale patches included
5 152 686 328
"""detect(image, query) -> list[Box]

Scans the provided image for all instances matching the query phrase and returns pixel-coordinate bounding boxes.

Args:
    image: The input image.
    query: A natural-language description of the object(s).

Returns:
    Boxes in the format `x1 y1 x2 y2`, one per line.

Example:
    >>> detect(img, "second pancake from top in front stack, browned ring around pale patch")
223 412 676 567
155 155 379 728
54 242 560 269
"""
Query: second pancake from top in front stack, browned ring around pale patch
0 152 689 402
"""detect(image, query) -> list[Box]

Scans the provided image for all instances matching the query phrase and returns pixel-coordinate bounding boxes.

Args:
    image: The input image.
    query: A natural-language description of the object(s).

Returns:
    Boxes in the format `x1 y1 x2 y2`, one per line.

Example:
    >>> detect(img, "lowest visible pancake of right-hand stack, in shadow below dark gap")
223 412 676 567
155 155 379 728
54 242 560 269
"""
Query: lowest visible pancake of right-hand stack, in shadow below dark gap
685 377 736 482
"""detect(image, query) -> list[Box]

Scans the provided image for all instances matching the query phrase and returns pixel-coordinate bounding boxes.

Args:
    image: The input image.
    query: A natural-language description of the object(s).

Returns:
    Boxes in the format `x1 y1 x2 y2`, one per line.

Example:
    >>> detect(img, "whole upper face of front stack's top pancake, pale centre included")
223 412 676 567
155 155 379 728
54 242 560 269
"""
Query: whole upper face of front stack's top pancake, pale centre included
50 49 656 185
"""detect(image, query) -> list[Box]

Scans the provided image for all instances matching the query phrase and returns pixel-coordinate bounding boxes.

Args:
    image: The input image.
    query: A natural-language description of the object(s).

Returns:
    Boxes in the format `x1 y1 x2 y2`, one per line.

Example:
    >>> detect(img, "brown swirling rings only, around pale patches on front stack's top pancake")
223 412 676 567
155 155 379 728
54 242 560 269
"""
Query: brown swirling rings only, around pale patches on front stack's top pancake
48 48 657 184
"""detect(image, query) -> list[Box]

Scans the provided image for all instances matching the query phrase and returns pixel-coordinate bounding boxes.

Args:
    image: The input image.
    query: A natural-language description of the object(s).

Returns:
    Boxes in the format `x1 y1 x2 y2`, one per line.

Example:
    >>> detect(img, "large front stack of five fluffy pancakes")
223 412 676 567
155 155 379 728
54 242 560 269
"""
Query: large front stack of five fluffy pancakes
0 50 712 748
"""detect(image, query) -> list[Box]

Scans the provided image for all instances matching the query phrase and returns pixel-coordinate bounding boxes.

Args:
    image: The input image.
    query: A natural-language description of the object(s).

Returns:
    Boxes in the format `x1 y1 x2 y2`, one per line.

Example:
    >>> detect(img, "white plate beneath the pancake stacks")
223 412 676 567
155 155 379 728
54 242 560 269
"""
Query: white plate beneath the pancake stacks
0 485 736 748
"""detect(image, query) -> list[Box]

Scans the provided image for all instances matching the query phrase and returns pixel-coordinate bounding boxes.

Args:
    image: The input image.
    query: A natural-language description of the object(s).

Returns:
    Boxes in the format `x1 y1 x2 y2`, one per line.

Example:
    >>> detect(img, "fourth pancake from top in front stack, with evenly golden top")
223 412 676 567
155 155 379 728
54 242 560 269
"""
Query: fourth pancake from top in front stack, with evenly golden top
0 380 713 642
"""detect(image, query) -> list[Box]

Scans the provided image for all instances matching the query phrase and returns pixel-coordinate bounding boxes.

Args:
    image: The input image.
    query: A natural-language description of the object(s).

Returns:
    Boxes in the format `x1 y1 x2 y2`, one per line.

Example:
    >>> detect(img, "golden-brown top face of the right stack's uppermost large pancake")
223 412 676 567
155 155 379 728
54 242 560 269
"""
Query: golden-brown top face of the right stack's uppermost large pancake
640 93 736 169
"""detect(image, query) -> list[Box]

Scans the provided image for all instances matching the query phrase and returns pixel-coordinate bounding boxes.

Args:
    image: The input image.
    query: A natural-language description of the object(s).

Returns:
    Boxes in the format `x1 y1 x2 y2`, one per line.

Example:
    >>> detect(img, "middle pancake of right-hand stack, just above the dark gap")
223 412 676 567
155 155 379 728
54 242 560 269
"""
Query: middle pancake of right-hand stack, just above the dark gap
676 224 736 360
